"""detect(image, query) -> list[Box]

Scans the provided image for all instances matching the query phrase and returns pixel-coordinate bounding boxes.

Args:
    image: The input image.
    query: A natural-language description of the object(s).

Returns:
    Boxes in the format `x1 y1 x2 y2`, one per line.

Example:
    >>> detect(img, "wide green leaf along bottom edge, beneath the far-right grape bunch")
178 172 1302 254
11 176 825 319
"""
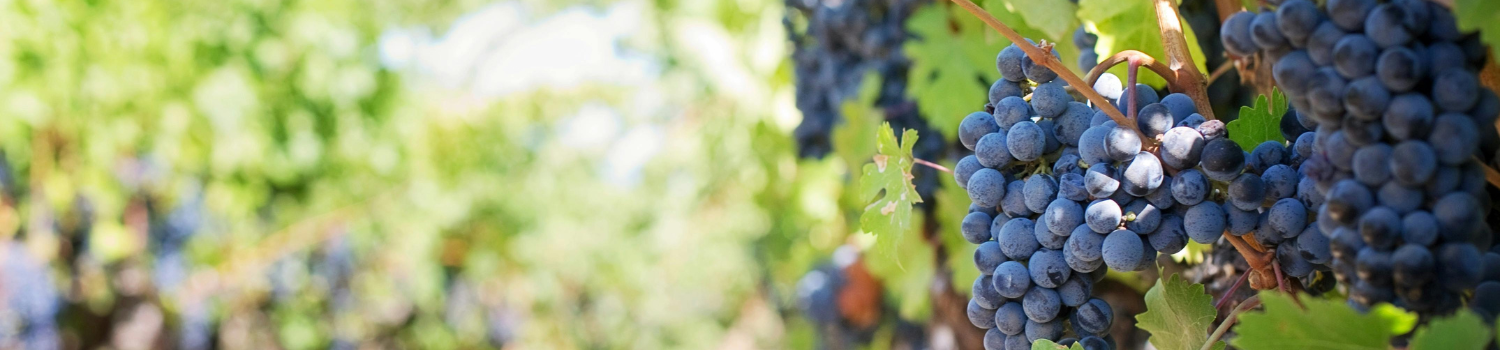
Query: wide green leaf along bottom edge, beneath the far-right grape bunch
1230 291 1416 350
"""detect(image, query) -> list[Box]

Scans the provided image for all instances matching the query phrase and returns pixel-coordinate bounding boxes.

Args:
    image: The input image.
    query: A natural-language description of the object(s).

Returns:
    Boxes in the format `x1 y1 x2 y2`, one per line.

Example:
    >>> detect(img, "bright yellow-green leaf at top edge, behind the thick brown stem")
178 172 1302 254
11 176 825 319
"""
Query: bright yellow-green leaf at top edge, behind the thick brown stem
1079 0 1208 87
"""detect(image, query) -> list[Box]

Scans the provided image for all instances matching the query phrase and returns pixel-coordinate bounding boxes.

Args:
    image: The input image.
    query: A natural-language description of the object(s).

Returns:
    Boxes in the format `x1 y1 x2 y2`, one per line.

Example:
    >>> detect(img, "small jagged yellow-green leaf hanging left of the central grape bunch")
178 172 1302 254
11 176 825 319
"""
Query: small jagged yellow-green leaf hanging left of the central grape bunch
860 123 923 236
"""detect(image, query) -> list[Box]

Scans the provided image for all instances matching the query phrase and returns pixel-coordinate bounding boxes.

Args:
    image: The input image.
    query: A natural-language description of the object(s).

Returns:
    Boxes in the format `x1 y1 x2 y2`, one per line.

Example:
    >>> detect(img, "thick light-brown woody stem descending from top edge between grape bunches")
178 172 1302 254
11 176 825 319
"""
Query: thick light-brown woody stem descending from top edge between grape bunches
1155 0 1214 120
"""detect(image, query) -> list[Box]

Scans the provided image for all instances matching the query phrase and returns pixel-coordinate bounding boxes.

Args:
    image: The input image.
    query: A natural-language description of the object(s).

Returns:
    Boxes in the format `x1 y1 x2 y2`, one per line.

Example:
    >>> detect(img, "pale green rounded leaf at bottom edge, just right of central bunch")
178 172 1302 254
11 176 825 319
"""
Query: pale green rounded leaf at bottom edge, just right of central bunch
1136 273 1224 348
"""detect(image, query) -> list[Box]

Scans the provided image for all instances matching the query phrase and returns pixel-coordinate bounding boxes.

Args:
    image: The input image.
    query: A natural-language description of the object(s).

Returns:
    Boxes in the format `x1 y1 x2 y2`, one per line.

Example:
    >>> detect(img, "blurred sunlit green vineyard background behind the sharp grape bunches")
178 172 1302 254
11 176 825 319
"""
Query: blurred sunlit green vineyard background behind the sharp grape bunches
0 0 1238 348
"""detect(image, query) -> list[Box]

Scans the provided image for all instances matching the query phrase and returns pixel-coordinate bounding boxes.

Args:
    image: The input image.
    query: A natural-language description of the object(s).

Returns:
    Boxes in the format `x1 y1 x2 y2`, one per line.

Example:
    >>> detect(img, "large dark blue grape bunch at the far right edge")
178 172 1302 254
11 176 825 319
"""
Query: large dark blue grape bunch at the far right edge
1221 0 1500 320
